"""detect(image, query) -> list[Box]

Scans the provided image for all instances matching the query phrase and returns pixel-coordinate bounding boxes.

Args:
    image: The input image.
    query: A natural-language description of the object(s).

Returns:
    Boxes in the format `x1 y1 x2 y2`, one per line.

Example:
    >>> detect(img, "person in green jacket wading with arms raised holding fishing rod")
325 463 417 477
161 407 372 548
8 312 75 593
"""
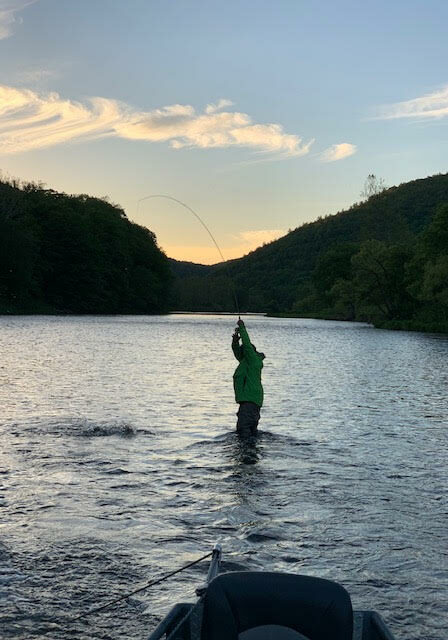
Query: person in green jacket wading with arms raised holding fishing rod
232 320 265 436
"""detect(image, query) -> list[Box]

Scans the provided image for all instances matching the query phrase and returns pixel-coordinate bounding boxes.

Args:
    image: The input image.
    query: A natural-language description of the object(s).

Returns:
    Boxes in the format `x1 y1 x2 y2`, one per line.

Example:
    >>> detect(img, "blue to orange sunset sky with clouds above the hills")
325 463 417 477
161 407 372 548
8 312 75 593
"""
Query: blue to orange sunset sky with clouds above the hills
0 0 448 264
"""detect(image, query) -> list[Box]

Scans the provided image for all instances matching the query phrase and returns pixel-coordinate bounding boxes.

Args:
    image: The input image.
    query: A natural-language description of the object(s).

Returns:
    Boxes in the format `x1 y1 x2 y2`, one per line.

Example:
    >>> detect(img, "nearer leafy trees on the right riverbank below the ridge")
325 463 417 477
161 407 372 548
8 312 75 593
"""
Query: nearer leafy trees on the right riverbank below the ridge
294 204 448 331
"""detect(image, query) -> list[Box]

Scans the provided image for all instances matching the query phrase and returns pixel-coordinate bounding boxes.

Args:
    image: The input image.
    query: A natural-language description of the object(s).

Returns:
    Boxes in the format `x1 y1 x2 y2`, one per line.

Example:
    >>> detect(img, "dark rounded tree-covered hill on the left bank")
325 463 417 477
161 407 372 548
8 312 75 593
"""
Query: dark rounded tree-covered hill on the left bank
0 181 173 313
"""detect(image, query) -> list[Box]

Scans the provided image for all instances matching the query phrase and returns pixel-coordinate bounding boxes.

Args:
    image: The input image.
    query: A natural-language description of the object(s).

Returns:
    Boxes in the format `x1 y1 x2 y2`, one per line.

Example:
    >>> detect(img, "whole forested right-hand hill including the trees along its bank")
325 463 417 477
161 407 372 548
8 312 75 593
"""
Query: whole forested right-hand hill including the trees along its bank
172 174 448 330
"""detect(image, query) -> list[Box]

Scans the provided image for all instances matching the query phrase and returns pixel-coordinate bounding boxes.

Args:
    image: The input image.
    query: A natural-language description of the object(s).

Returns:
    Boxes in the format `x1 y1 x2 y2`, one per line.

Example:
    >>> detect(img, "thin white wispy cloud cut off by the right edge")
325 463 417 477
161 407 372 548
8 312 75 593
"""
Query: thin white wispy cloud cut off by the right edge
376 85 448 120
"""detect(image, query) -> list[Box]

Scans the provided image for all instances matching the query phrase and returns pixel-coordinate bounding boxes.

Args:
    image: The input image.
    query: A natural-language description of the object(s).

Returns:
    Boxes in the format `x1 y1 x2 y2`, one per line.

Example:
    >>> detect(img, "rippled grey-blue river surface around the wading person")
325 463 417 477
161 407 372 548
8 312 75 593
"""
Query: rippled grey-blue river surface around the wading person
0 315 448 640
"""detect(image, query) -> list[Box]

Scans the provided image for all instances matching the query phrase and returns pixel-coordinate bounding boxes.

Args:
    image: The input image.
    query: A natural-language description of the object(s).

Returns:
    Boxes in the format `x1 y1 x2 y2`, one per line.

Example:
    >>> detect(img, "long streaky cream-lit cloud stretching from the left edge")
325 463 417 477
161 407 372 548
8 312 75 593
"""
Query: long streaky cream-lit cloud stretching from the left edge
0 85 312 157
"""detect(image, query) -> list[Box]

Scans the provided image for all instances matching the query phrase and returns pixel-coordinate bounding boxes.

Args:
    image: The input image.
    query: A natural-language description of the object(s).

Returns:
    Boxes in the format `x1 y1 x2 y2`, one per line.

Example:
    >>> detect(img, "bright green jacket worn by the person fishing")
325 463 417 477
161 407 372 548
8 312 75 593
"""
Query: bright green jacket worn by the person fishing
232 327 263 407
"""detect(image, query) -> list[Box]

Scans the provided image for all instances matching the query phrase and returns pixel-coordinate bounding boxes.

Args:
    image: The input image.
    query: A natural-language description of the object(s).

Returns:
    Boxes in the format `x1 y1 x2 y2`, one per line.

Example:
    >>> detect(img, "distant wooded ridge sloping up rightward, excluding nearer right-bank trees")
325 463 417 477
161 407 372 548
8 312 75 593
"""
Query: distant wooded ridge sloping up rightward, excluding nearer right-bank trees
174 173 448 328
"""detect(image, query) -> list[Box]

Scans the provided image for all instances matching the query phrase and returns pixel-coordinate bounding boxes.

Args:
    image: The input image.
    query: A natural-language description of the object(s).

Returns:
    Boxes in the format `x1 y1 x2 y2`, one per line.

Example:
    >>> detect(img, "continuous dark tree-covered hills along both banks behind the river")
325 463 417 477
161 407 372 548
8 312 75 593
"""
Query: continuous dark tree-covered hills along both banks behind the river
0 174 448 331
